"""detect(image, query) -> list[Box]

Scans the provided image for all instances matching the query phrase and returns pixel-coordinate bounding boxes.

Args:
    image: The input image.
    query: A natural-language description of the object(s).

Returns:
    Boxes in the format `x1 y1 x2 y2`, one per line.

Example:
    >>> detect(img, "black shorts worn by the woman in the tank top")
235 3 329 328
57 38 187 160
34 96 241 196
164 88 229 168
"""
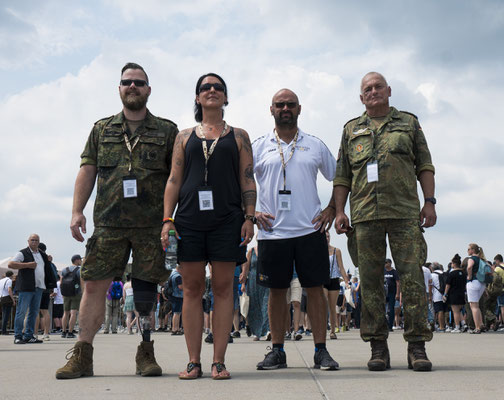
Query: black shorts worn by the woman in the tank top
176 217 247 265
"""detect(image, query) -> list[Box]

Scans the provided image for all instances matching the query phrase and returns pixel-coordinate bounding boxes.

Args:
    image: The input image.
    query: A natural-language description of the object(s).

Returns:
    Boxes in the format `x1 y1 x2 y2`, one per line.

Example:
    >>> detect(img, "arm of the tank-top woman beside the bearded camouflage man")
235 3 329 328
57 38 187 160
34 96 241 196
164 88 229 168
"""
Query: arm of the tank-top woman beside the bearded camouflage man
161 129 192 247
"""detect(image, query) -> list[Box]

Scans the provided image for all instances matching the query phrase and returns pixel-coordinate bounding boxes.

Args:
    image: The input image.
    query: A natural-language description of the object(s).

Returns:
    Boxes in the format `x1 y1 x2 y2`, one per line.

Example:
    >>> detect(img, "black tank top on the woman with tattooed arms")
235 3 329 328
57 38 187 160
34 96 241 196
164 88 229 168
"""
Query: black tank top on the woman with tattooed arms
175 128 243 231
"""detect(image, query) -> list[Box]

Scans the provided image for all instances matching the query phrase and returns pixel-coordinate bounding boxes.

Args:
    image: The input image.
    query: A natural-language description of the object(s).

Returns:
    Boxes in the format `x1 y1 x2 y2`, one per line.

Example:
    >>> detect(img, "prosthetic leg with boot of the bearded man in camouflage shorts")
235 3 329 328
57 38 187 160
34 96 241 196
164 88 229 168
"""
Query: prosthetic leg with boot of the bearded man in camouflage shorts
131 278 162 376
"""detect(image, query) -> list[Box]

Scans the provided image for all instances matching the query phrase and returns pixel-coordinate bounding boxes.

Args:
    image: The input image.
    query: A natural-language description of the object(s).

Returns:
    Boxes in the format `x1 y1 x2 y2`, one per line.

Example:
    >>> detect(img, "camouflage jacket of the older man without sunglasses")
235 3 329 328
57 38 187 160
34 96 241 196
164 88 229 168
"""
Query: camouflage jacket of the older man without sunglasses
333 107 434 223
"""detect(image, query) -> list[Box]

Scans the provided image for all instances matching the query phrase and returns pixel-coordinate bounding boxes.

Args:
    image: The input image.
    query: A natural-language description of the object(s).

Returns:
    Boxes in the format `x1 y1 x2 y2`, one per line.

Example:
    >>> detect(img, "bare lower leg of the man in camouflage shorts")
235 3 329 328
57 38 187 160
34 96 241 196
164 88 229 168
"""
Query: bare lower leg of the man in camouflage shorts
78 278 112 343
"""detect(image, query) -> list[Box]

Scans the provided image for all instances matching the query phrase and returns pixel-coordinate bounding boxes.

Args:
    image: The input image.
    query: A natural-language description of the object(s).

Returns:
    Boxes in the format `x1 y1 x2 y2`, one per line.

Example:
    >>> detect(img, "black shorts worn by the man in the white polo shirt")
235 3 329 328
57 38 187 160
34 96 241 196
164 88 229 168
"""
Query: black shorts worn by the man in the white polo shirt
257 231 330 289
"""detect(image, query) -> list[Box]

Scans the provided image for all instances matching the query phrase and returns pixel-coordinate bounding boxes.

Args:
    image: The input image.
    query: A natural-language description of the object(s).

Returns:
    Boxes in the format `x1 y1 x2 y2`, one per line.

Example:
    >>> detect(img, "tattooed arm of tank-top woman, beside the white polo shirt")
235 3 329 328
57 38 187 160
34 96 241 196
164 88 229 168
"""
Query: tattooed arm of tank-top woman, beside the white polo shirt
235 128 257 245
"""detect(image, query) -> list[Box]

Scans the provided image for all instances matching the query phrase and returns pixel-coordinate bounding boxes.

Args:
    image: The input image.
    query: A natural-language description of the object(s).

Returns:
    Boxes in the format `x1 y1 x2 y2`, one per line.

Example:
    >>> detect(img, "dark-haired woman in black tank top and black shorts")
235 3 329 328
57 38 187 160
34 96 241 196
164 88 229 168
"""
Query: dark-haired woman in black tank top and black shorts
161 73 256 379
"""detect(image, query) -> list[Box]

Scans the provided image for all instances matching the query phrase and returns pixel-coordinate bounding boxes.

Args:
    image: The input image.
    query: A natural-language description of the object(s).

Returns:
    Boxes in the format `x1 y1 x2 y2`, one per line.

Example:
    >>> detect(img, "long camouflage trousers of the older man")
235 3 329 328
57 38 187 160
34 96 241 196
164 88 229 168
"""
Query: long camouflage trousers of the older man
348 219 432 342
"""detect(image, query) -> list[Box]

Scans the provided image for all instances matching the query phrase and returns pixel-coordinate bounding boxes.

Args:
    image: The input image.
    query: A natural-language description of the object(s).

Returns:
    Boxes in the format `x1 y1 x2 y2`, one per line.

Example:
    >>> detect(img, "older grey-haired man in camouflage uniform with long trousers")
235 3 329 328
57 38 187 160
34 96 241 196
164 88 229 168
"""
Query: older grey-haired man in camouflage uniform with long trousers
333 72 436 371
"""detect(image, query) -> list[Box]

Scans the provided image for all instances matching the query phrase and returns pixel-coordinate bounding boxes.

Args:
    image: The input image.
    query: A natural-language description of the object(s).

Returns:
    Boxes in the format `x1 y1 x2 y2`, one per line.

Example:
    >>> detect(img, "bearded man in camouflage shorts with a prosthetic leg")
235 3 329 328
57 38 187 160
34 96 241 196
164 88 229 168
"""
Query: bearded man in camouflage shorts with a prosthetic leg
56 63 178 379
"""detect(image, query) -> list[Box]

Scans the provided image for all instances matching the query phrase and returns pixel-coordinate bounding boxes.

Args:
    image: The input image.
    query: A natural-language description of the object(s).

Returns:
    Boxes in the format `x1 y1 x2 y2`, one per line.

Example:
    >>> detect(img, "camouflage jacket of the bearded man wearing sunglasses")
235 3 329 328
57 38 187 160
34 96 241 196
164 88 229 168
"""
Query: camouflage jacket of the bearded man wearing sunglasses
81 111 178 228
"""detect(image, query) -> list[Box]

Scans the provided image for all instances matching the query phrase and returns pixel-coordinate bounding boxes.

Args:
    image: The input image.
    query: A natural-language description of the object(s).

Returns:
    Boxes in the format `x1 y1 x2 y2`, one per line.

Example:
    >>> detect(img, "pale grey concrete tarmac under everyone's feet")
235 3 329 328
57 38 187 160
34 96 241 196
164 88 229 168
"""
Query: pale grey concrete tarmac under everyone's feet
0 330 504 400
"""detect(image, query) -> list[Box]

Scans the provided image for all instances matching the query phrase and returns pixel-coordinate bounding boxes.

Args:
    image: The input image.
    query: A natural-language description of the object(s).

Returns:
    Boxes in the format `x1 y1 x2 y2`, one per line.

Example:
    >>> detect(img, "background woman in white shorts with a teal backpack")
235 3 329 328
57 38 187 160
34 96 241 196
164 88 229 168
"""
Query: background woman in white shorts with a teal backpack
467 243 486 334
